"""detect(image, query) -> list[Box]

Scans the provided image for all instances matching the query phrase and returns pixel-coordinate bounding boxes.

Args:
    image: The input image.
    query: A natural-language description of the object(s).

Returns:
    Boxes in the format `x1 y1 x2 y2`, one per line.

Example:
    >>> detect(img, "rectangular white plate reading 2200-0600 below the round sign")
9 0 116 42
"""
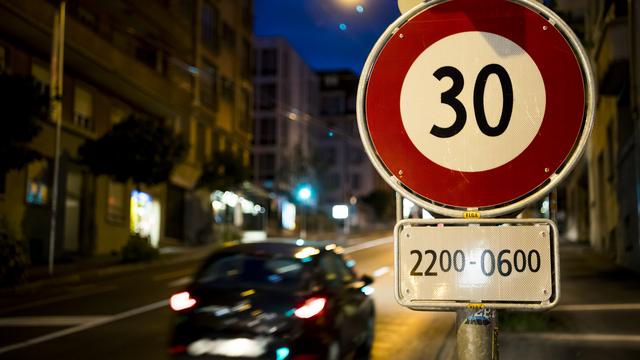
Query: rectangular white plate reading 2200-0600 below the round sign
395 219 559 309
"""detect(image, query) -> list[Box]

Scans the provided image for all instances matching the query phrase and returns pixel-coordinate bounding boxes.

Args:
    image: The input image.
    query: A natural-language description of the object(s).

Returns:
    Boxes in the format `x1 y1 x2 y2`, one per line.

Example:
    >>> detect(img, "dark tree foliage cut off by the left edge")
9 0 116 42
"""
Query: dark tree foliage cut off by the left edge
0 73 49 176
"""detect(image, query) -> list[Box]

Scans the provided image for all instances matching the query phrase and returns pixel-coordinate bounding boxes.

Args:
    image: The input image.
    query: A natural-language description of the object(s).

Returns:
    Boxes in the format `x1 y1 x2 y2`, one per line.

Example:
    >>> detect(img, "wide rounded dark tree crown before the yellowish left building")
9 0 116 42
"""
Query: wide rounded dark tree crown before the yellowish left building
80 115 188 185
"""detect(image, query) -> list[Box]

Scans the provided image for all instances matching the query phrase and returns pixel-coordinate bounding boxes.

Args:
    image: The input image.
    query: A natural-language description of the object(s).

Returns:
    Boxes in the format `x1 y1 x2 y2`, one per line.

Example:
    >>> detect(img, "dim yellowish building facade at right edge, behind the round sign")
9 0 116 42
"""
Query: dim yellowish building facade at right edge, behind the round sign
558 0 640 270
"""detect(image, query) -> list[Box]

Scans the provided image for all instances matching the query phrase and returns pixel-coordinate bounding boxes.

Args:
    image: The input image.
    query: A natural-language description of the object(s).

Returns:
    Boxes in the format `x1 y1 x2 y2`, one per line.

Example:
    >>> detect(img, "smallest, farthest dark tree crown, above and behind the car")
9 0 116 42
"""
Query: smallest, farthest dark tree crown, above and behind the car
198 151 250 191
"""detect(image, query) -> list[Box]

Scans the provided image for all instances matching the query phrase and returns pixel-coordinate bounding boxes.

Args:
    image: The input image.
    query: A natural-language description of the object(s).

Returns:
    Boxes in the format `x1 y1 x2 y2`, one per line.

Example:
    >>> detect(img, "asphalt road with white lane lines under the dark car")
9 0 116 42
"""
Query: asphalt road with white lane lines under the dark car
0 237 455 360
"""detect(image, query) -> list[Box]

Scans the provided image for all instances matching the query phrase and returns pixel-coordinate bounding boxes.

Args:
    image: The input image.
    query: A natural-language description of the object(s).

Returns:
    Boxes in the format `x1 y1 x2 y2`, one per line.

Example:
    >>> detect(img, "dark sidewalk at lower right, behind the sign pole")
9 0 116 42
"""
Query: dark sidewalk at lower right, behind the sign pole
437 242 640 360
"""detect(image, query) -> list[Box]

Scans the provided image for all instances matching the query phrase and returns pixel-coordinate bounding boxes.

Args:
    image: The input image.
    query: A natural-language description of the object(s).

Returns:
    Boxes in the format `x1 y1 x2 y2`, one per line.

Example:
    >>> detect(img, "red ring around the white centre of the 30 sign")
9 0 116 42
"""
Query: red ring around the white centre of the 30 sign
364 0 585 208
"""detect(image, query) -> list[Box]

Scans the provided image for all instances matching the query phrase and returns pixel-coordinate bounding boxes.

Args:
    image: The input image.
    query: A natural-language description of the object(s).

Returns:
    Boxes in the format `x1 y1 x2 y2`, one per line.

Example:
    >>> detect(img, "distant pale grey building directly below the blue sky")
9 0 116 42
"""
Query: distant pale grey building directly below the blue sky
252 37 318 234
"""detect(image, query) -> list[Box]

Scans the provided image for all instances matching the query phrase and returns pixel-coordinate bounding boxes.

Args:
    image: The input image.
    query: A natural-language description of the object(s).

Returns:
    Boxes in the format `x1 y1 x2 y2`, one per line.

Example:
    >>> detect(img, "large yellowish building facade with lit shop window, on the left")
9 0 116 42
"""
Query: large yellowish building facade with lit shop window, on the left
0 0 253 261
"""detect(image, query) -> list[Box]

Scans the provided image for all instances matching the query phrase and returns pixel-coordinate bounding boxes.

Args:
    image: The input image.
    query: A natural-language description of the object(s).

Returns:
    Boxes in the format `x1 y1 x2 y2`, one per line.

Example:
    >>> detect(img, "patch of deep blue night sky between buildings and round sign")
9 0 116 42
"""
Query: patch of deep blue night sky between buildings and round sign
254 0 400 74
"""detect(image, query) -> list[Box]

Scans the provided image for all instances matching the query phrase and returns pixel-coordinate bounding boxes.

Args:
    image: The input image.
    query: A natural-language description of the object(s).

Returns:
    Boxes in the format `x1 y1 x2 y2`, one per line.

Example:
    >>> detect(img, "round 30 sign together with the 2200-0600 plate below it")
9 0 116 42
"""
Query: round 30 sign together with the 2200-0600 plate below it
357 0 595 310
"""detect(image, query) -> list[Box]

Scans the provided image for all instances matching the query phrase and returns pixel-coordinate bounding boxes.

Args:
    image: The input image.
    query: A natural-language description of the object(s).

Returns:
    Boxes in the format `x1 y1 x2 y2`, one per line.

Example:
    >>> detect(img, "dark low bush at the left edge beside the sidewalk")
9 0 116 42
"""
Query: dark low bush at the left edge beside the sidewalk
0 235 29 287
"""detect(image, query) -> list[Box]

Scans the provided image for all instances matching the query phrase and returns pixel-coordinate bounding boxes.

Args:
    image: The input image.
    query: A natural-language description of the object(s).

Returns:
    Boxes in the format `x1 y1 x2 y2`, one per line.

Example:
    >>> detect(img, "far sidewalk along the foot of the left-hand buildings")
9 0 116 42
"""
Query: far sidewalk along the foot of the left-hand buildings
0 231 390 296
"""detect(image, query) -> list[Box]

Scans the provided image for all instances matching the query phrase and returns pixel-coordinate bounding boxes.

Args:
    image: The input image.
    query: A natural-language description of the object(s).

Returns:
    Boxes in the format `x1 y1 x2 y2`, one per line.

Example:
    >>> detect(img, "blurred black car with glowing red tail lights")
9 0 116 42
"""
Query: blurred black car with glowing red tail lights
170 240 375 360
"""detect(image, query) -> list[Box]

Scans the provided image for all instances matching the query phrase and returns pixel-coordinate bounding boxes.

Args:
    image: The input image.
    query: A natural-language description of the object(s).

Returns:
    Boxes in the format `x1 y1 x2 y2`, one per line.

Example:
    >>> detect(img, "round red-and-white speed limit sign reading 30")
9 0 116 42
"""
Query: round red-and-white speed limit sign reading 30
358 0 595 217
